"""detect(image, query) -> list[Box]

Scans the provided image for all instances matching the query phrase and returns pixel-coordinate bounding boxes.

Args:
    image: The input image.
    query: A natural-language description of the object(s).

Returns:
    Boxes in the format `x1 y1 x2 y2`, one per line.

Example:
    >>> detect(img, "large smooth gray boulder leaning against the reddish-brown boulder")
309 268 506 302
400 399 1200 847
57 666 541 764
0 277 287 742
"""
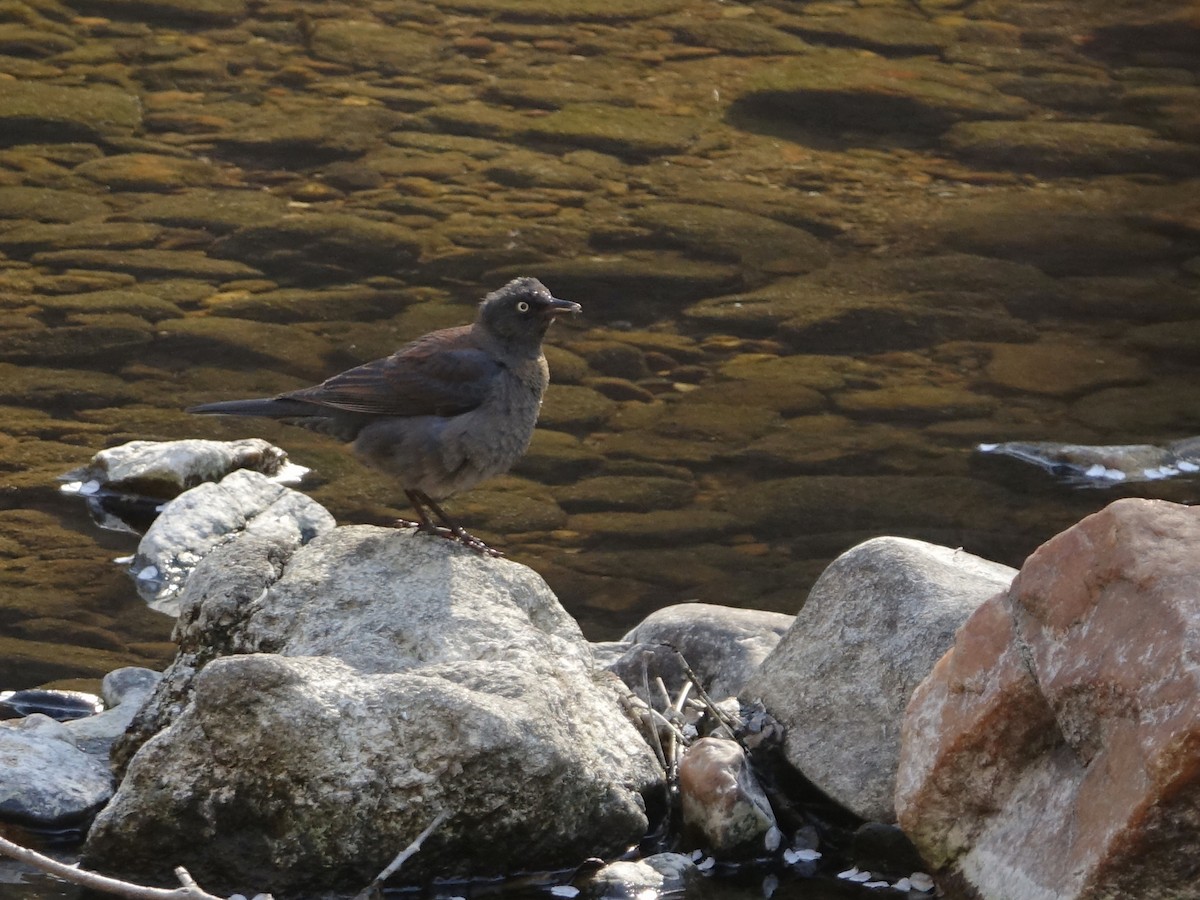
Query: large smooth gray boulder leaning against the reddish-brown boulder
742 538 1016 822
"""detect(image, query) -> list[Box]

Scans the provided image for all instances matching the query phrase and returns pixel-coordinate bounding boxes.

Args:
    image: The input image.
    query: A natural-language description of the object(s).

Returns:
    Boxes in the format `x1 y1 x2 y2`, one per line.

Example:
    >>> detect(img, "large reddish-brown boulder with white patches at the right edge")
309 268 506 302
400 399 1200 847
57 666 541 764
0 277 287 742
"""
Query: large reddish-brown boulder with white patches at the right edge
896 499 1200 900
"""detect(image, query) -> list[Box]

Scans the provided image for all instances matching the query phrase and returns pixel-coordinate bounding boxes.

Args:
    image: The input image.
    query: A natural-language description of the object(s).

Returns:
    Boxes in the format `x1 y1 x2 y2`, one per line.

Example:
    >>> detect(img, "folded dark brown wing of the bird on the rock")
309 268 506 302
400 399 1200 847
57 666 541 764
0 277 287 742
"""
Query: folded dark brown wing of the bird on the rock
282 328 503 415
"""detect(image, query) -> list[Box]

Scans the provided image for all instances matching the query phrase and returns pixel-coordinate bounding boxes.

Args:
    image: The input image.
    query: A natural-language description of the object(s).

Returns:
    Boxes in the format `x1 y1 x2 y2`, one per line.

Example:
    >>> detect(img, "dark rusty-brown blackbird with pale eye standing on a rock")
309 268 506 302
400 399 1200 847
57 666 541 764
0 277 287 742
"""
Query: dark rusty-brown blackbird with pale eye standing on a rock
188 278 580 556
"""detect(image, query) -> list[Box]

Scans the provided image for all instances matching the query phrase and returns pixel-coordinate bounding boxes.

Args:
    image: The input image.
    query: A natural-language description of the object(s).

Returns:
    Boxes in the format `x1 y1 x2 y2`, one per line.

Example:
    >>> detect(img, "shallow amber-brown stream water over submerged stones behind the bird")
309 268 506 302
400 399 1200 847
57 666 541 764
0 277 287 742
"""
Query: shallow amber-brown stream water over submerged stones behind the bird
0 0 1200 897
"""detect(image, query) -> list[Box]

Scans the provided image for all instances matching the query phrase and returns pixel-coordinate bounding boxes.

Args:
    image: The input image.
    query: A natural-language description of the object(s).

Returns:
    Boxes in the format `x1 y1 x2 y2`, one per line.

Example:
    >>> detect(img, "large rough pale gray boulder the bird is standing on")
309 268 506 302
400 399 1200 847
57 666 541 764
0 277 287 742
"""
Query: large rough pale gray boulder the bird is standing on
85 527 662 895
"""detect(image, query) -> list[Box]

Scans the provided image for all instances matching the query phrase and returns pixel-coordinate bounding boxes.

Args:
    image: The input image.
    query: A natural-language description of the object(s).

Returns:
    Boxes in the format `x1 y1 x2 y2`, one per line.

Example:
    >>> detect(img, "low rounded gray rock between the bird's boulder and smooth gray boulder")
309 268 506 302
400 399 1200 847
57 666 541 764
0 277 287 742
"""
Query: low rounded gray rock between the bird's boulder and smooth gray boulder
606 604 794 706
